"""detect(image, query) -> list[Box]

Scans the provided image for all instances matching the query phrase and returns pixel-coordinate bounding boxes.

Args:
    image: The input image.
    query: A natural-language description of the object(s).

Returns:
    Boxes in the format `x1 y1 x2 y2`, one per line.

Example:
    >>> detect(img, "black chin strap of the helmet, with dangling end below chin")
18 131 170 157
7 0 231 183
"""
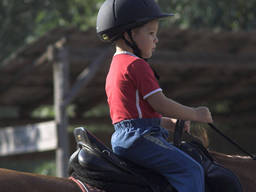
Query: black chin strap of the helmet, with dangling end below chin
122 29 160 80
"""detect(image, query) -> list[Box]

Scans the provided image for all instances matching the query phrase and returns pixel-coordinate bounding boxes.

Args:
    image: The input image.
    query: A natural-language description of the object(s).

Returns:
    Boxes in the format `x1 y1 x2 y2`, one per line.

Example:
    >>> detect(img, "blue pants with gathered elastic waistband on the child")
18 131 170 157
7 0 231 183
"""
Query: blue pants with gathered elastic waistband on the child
111 119 204 192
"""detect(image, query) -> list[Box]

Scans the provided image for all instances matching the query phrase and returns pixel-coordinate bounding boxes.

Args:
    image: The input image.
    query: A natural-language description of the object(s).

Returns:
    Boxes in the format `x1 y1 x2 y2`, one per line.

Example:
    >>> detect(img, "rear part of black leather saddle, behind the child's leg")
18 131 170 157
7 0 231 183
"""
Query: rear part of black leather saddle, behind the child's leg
69 127 177 192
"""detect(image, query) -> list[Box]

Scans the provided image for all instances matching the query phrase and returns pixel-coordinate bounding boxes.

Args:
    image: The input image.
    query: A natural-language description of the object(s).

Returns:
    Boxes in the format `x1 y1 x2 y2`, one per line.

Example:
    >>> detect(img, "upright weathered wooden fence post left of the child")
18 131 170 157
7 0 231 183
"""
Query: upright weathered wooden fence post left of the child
50 39 69 177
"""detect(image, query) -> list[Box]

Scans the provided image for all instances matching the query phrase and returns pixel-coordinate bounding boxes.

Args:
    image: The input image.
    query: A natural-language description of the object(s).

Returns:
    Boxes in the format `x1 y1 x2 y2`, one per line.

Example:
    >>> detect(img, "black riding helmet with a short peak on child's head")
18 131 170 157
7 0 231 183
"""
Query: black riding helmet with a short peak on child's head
97 0 173 42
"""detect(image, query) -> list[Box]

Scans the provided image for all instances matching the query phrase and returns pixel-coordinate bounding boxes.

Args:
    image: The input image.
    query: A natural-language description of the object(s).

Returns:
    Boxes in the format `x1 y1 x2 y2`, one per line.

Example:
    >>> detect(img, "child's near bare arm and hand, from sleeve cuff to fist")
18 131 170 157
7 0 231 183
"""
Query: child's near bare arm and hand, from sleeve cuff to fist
147 91 212 123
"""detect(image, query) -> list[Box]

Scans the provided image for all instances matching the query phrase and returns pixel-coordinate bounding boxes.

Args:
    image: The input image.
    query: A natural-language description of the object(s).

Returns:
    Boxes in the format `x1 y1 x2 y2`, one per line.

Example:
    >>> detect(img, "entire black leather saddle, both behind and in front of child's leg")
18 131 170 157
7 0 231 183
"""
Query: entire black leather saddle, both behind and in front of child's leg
69 121 242 192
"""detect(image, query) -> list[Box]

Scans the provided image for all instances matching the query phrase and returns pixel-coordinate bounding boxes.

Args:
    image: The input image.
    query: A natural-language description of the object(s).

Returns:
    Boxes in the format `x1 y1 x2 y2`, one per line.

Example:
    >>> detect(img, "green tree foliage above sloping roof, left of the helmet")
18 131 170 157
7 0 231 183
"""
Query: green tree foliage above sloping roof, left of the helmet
0 0 104 61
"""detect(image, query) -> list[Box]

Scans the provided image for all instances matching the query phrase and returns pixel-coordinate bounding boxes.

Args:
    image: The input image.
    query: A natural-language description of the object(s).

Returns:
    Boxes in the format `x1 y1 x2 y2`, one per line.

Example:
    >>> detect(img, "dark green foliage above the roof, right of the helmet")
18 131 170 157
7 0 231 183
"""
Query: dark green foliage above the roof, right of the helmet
158 0 256 31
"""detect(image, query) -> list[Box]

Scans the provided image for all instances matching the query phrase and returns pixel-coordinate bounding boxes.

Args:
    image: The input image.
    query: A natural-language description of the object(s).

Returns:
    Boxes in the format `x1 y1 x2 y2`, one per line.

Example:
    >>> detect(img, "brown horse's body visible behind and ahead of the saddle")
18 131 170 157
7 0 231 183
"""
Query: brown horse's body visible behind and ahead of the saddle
0 151 256 192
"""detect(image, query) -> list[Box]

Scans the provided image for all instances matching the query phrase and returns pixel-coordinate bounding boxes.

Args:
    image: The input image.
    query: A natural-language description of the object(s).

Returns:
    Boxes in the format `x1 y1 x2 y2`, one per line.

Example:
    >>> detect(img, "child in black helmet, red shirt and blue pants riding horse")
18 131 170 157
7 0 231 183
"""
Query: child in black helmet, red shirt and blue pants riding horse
97 0 212 192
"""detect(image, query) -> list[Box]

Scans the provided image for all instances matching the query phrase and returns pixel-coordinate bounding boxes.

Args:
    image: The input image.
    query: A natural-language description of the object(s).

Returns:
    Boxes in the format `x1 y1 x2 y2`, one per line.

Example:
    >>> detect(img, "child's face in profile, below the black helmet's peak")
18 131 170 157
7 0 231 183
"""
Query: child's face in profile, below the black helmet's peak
132 20 158 58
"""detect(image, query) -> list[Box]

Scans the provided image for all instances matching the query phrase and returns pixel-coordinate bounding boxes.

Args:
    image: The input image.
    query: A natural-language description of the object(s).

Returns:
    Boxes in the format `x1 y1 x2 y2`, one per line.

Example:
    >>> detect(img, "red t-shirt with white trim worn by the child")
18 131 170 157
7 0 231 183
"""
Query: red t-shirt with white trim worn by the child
105 52 162 124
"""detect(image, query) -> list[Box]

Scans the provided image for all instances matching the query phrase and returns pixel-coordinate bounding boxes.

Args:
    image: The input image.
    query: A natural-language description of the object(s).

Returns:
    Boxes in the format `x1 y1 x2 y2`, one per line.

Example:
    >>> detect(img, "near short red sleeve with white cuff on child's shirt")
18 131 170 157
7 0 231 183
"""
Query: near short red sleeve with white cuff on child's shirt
128 59 162 99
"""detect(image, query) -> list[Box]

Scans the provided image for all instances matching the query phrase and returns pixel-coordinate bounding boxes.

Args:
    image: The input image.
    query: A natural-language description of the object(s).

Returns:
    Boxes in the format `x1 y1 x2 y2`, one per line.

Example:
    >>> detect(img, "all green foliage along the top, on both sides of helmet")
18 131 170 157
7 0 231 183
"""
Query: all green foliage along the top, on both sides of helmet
0 0 256 61
